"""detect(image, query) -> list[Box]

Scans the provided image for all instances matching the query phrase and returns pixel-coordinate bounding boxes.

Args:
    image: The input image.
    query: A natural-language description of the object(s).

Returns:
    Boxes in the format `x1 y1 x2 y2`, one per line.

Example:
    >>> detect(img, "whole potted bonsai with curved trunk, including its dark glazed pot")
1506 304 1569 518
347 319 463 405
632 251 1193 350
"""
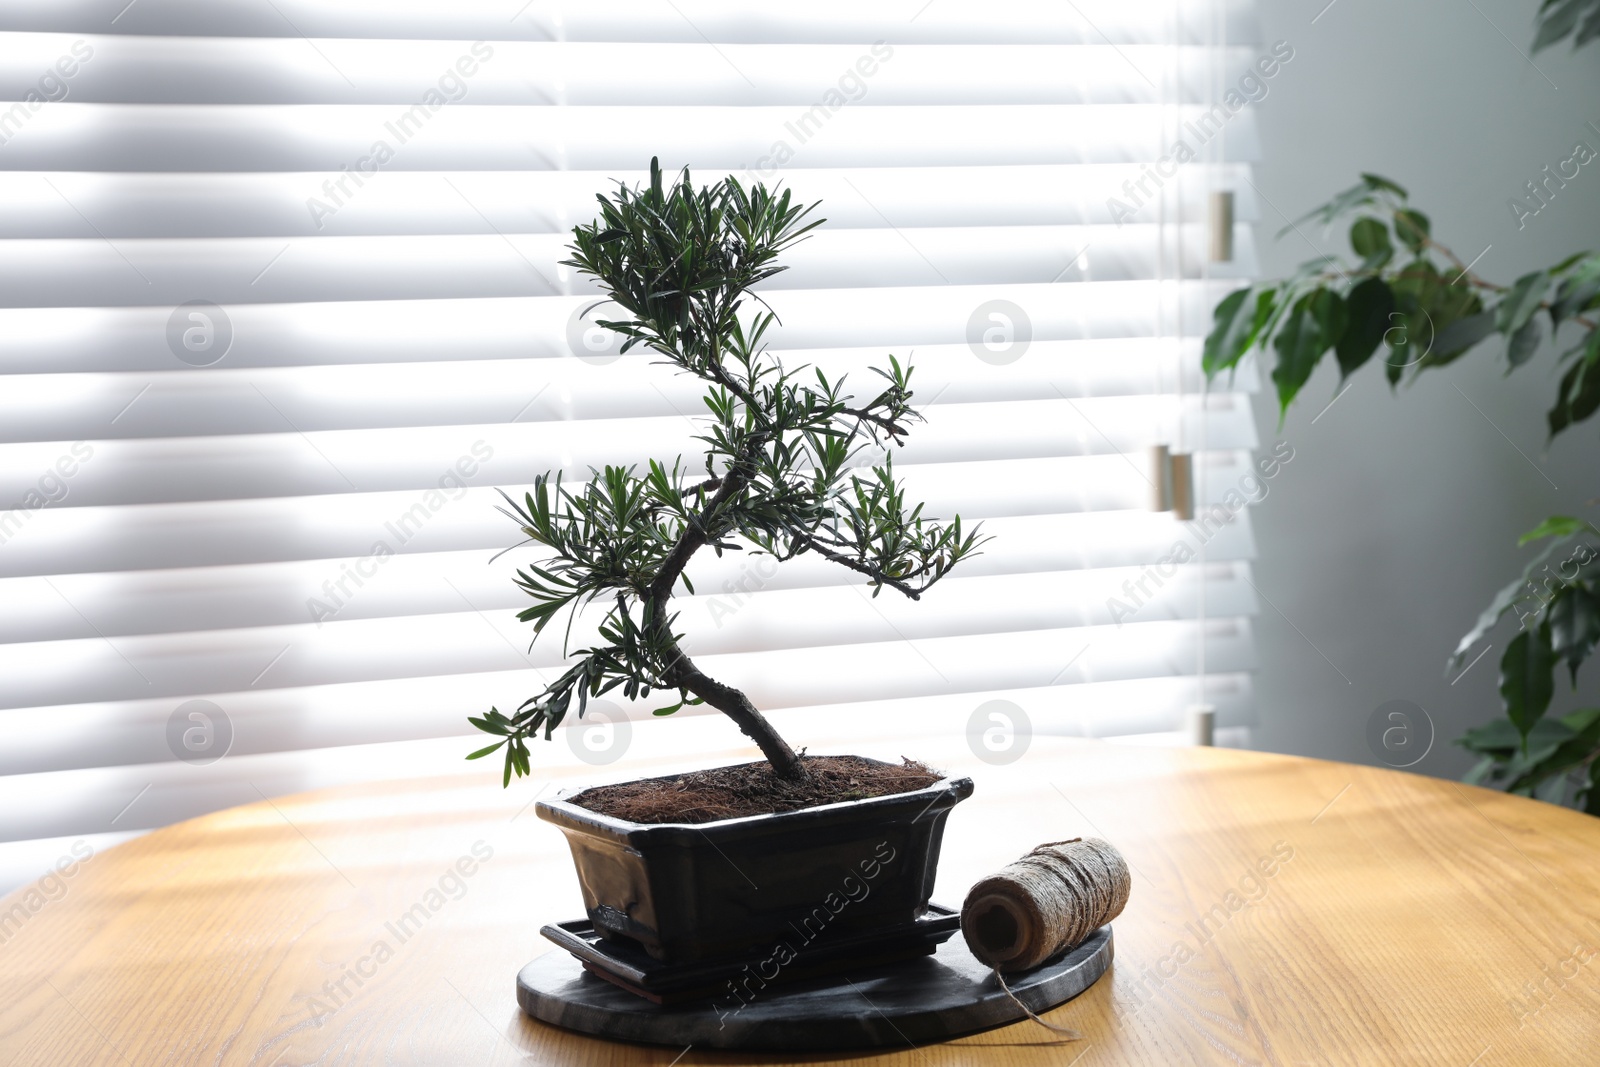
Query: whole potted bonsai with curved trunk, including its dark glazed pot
470 160 981 961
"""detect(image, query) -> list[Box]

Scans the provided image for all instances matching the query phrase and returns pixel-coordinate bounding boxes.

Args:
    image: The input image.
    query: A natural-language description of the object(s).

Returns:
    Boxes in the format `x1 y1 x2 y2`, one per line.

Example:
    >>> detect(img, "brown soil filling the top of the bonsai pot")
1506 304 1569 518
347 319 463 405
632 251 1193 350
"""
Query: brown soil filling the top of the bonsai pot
568 755 941 822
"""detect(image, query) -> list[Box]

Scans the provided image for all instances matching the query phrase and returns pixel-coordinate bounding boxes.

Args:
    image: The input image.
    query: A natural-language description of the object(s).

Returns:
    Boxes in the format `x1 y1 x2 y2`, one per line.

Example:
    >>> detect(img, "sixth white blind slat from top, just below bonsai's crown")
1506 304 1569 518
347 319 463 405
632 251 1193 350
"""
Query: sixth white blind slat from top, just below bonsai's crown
0 282 1254 378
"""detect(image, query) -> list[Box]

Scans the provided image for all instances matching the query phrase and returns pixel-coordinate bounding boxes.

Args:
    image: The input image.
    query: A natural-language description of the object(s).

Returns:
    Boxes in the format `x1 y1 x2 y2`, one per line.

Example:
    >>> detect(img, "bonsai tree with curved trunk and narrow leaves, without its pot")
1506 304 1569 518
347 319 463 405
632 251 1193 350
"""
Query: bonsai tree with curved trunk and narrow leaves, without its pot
467 160 981 784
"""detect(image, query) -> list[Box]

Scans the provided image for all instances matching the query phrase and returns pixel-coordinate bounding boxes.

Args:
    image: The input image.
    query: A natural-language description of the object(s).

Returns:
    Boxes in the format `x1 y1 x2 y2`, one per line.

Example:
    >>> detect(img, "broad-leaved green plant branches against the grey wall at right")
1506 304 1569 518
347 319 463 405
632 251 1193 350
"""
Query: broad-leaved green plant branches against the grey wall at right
1202 171 1600 814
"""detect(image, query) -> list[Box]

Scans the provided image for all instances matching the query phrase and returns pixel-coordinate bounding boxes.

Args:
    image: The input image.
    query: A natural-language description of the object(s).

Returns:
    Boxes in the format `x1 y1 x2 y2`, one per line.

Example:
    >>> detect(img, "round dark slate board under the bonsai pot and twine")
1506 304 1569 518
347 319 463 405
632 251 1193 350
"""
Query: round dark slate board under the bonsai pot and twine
517 926 1112 1049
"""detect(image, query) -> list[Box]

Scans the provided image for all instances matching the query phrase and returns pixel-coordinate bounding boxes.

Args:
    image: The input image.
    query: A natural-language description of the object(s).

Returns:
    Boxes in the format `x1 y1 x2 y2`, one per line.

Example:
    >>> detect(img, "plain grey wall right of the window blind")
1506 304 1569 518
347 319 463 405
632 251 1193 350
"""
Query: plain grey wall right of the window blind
1253 0 1600 777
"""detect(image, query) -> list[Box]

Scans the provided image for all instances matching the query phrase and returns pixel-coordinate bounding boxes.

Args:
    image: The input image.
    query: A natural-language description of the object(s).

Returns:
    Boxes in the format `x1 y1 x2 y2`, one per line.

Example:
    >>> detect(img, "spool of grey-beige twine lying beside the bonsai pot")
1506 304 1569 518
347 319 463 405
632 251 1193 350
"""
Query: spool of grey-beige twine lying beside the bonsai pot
962 837 1133 979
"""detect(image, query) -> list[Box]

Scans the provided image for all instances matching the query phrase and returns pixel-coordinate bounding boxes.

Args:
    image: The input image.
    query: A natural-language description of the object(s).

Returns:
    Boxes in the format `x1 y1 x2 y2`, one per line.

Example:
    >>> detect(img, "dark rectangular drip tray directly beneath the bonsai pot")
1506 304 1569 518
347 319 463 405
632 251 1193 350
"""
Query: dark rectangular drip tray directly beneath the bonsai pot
539 904 962 1005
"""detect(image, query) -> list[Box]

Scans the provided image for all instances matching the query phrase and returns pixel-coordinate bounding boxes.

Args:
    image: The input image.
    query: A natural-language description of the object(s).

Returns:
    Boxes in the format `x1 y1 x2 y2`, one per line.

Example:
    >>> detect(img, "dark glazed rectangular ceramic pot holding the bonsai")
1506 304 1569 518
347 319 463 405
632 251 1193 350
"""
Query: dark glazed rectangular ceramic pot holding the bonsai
538 758 973 963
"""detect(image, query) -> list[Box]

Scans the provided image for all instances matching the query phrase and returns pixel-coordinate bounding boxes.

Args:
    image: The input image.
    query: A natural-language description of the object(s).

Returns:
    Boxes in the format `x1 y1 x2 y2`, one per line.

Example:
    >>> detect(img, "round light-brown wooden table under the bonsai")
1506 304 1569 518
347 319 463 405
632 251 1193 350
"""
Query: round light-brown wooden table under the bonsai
0 734 1600 1067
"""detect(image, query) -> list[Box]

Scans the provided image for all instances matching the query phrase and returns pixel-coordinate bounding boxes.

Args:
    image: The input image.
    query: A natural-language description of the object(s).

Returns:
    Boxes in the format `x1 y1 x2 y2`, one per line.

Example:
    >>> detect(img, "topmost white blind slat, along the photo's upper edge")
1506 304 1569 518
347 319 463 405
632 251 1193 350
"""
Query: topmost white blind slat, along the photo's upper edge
0 0 1254 45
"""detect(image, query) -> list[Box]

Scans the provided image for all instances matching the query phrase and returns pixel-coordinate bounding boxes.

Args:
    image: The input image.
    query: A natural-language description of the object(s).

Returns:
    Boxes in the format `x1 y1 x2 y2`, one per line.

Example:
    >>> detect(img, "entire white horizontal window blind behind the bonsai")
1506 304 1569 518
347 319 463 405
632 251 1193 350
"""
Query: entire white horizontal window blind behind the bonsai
0 0 1262 885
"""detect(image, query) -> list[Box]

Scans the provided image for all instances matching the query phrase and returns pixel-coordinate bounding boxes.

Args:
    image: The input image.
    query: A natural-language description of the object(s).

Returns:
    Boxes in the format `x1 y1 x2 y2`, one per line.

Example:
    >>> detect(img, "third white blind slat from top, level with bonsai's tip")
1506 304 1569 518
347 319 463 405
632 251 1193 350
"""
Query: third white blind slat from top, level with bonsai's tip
5 99 1256 171
